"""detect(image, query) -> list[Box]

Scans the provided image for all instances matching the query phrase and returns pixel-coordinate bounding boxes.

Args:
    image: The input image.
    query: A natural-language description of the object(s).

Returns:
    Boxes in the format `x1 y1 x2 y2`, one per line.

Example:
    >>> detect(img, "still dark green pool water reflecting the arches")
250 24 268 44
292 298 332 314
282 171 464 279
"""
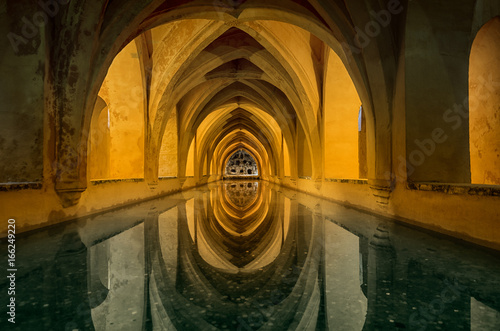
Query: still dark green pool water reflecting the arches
3 181 500 330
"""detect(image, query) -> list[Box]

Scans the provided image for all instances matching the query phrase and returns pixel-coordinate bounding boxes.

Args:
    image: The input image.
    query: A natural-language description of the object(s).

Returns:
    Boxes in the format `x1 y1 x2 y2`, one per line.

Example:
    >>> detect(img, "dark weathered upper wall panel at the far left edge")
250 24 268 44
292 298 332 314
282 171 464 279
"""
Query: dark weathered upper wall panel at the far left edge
0 1 46 183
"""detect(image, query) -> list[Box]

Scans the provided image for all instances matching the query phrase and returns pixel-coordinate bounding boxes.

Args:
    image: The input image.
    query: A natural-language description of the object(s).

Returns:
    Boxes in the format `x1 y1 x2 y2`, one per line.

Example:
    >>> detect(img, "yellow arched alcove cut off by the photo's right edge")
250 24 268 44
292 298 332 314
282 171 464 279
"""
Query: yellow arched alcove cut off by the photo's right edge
469 16 500 185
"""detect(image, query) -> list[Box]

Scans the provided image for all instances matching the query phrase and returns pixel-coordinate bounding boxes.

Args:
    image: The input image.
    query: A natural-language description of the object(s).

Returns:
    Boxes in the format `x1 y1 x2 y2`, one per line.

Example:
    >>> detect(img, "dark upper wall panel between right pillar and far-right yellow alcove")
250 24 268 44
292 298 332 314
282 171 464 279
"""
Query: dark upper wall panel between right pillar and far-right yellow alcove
404 0 474 183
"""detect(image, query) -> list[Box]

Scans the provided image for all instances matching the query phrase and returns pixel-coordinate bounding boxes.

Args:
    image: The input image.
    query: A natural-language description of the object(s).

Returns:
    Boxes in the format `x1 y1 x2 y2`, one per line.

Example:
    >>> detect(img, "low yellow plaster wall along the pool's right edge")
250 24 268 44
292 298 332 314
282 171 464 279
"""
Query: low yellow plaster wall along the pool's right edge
281 178 500 249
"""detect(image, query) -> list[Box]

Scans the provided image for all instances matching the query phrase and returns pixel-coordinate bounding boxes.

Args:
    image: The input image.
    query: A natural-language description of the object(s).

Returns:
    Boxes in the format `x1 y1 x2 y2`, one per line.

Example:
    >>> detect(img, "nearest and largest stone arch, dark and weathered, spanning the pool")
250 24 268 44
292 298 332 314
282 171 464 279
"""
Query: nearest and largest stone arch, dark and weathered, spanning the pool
41 0 395 204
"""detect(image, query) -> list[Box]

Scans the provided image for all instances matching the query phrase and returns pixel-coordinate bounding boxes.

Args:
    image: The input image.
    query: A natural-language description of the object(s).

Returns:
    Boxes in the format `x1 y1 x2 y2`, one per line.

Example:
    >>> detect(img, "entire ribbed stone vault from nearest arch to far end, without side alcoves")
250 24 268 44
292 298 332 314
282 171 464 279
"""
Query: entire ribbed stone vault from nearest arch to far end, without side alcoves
47 0 396 204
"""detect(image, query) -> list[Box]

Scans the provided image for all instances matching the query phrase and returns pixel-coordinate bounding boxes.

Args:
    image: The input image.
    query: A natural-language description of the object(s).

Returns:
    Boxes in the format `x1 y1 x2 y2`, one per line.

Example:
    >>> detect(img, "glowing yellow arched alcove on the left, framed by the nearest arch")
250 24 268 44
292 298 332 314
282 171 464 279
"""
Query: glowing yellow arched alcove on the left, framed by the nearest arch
89 41 144 179
